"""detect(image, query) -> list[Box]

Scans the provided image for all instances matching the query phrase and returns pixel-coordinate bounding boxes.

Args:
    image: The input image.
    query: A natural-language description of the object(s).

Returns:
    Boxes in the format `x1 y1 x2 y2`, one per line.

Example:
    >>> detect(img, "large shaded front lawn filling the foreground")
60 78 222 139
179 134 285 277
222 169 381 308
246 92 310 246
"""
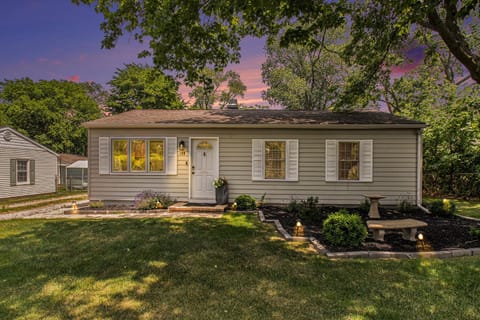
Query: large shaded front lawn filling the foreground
0 214 480 319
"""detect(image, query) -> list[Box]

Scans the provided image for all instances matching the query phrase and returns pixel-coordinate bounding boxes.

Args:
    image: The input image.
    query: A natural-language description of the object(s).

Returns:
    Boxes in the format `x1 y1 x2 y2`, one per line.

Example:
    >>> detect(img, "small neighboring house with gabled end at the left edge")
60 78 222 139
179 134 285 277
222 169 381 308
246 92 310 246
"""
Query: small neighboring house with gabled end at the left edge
0 127 58 199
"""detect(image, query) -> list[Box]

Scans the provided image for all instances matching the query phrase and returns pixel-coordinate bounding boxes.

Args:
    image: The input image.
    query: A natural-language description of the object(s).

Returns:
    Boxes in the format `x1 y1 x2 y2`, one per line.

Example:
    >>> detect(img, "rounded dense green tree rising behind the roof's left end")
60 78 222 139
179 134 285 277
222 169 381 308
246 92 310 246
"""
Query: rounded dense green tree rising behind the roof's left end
107 64 185 113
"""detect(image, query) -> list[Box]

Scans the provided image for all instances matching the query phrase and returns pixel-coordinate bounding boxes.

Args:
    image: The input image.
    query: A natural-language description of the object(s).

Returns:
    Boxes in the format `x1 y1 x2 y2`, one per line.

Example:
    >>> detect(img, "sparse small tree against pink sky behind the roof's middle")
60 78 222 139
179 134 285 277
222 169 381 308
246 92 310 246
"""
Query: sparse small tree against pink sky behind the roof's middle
189 68 247 109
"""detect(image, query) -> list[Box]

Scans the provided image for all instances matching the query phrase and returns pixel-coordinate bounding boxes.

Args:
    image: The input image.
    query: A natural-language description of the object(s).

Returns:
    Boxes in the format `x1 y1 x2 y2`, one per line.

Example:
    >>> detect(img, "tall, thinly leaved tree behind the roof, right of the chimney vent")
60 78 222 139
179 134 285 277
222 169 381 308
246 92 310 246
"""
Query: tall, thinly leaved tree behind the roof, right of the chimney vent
262 25 348 110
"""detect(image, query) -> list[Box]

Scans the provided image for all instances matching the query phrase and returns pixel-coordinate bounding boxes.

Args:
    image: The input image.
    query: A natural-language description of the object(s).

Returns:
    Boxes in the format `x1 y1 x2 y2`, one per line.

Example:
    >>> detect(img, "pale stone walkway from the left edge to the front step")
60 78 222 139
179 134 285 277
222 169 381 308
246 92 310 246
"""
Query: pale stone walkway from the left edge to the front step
0 200 223 220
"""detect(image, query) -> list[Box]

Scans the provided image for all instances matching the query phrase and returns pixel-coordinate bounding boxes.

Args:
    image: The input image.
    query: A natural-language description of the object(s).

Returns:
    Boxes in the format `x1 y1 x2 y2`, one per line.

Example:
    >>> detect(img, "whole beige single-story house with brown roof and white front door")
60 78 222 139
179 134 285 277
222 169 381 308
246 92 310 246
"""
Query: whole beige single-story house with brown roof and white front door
84 110 425 205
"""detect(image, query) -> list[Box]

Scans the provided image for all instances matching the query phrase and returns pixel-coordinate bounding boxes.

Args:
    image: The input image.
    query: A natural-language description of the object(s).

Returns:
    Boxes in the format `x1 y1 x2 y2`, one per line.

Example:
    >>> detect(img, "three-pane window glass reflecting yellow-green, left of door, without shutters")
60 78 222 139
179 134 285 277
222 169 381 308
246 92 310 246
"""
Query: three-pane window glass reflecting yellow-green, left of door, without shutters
112 139 165 173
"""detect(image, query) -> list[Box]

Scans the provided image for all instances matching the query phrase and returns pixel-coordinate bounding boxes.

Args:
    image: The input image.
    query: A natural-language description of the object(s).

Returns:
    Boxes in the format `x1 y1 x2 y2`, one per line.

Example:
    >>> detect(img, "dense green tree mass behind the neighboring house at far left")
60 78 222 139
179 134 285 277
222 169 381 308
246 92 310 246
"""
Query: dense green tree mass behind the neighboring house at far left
0 78 100 155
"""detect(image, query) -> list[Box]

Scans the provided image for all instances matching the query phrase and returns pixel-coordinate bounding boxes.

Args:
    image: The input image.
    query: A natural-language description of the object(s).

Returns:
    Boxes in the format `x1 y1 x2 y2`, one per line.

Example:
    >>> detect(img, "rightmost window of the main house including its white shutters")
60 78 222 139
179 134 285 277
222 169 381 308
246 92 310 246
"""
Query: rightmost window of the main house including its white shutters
325 140 373 182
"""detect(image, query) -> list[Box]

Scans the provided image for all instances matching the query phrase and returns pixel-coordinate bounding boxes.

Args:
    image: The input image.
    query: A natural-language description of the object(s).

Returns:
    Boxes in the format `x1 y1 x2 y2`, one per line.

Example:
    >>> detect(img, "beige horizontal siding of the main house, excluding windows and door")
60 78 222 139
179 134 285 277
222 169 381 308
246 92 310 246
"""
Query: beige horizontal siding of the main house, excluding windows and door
89 129 417 205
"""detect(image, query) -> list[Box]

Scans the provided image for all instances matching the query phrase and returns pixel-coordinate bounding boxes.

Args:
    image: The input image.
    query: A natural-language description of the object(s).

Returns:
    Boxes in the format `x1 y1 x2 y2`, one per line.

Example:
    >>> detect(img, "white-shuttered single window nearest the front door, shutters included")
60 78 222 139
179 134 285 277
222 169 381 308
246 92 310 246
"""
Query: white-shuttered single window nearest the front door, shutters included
252 139 298 181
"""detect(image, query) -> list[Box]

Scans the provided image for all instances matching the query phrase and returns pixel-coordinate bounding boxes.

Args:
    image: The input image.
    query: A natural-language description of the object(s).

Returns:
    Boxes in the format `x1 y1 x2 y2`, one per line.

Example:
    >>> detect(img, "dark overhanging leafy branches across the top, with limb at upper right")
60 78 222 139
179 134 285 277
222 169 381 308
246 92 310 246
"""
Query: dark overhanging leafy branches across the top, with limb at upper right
72 0 480 99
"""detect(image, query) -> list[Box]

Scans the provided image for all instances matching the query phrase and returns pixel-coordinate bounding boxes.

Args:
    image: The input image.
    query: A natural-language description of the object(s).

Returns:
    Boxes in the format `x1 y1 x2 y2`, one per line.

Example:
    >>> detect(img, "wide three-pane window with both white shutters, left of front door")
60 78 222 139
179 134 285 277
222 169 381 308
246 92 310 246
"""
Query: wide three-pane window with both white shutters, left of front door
98 137 177 175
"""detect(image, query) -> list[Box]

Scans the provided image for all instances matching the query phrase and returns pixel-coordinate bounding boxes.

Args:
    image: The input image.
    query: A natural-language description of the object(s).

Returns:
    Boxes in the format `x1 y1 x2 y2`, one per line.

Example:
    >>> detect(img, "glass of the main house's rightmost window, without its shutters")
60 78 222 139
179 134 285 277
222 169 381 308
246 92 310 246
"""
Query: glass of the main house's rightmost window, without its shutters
338 142 360 180
